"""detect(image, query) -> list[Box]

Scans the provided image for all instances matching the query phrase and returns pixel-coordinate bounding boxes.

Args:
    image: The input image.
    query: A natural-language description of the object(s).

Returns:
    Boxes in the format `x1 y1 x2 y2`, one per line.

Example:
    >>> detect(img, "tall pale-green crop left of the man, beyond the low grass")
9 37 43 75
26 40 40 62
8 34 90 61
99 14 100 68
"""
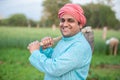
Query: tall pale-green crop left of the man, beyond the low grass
0 27 60 49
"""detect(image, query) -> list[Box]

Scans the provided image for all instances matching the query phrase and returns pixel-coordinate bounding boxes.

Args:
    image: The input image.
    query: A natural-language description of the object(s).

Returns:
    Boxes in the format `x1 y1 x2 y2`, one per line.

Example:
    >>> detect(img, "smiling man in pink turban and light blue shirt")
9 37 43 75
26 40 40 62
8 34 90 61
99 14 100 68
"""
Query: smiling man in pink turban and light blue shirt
28 3 92 80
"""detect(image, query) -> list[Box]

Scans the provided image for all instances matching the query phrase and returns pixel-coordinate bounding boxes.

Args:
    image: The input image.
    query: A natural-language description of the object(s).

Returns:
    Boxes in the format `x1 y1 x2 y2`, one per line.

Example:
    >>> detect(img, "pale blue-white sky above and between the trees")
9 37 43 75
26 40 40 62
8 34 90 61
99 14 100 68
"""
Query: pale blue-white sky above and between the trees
0 0 120 20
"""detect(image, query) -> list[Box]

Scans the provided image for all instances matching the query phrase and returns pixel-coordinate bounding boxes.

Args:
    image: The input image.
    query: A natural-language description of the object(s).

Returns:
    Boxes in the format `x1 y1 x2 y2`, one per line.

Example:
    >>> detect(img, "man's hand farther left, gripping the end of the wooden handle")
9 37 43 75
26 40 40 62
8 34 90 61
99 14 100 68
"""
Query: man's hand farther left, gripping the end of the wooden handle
27 41 40 53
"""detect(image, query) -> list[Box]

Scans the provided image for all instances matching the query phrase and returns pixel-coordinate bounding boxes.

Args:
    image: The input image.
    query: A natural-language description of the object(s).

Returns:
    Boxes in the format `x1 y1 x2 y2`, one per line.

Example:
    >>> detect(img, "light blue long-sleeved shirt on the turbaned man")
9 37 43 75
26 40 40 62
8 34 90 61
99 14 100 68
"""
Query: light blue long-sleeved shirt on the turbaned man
29 32 92 80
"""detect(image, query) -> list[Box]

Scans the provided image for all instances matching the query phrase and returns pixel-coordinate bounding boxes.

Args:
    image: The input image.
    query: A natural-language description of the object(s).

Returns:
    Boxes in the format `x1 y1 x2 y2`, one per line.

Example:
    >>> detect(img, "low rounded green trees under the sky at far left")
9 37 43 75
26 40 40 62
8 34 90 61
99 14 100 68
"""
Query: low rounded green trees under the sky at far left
0 14 38 27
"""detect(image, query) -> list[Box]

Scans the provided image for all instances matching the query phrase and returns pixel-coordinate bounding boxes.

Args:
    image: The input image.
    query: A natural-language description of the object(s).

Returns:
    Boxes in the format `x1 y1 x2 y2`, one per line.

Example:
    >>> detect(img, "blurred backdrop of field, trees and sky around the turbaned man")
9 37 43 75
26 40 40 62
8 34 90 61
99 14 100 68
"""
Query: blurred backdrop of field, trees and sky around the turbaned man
0 0 120 80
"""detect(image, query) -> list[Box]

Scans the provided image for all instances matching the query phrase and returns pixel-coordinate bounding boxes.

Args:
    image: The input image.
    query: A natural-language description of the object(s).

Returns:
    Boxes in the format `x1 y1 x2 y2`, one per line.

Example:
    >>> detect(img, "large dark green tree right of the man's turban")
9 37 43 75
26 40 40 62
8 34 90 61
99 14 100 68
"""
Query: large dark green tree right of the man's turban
83 3 119 28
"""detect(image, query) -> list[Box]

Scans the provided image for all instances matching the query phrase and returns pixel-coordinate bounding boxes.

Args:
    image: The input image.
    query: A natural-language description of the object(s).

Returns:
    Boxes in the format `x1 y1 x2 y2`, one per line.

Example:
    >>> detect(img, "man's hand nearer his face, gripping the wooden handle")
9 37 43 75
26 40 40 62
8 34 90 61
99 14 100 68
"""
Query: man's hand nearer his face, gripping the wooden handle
41 37 54 49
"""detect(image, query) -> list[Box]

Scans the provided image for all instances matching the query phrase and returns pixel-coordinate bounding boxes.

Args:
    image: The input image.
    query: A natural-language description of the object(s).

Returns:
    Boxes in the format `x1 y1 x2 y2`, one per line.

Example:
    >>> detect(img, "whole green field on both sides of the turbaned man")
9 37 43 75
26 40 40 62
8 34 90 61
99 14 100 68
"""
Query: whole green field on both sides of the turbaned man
0 27 120 80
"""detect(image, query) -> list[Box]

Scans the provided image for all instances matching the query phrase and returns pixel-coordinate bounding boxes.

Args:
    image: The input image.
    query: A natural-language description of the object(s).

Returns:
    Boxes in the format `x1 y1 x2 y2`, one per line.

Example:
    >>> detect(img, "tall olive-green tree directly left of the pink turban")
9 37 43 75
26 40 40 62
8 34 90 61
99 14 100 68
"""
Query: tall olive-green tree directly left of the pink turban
40 0 71 26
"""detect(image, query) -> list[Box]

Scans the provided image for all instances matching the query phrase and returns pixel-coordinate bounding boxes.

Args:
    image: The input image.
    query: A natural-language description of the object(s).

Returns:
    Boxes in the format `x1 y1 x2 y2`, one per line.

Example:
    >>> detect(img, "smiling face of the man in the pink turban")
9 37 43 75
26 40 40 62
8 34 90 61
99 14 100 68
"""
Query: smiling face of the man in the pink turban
60 14 81 37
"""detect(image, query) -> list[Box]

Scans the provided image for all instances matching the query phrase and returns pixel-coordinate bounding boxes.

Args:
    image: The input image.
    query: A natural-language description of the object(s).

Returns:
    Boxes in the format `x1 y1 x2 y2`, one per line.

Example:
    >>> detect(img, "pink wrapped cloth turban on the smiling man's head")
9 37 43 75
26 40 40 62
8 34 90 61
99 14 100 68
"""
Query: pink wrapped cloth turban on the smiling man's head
58 3 86 26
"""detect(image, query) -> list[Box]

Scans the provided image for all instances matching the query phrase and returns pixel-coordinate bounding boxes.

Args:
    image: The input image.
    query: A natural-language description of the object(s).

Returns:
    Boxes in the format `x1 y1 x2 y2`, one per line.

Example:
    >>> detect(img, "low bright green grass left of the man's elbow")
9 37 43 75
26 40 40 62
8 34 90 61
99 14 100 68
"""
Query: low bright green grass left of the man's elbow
0 48 44 80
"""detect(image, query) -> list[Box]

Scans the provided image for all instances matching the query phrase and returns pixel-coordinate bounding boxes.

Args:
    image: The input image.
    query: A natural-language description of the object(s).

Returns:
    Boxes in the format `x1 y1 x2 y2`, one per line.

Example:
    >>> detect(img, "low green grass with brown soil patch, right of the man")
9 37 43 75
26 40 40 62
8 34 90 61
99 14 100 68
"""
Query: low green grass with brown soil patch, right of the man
88 54 120 80
